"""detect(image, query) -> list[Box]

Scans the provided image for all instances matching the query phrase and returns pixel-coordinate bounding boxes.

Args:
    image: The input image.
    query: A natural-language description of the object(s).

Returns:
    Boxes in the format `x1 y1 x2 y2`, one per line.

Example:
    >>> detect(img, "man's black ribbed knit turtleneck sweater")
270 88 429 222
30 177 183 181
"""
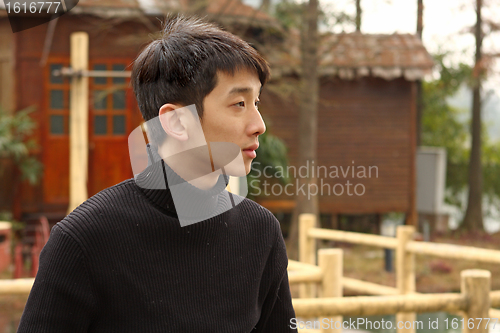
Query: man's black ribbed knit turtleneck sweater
18 156 296 333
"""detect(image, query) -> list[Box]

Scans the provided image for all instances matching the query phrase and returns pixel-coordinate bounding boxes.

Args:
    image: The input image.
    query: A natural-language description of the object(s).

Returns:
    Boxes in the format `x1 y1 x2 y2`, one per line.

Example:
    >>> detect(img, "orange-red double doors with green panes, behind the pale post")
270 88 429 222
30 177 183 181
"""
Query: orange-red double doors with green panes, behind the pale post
42 58 142 206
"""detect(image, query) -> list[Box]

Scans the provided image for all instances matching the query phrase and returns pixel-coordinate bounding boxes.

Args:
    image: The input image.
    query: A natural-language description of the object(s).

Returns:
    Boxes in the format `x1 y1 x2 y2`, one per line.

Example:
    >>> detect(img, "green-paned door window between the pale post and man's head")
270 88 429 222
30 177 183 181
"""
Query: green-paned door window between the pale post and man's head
91 62 128 136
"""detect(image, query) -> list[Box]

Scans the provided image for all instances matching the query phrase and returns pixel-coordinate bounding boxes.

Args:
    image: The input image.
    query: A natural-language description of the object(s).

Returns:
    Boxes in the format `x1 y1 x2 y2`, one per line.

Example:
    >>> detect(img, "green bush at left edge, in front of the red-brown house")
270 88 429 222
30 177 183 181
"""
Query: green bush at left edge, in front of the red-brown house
0 107 42 184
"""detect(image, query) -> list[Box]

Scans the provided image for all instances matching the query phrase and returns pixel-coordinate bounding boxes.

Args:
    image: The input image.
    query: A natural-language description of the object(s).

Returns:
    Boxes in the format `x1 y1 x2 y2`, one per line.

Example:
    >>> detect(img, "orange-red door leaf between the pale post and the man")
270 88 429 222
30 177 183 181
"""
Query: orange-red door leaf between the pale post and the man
88 59 139 196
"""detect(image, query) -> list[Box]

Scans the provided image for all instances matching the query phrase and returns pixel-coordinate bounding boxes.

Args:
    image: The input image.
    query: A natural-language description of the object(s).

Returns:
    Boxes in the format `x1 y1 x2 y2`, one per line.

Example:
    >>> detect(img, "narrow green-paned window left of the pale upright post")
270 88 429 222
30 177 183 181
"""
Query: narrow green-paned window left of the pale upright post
47 62 70 136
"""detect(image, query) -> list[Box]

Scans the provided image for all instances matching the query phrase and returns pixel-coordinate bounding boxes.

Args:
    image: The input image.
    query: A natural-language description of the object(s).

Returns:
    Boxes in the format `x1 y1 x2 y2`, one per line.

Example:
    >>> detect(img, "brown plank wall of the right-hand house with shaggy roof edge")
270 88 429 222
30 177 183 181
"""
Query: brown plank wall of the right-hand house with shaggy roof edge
258 77 415 214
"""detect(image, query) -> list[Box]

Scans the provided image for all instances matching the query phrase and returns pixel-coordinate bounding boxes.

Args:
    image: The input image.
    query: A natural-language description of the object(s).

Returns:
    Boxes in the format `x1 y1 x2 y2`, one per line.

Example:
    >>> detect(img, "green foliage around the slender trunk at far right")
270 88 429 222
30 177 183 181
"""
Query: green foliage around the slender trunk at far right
422 54 500 209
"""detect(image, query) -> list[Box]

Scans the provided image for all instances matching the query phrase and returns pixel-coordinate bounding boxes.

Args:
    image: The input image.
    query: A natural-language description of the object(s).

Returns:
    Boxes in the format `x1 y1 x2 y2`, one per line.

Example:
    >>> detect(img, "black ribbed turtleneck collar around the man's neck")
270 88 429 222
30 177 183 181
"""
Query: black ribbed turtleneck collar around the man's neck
135 145 231 220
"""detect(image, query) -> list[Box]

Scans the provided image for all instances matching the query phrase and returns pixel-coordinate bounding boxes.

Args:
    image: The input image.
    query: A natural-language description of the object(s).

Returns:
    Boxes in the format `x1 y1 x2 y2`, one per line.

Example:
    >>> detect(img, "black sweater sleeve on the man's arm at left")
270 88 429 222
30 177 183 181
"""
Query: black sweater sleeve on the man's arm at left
17 225 96 333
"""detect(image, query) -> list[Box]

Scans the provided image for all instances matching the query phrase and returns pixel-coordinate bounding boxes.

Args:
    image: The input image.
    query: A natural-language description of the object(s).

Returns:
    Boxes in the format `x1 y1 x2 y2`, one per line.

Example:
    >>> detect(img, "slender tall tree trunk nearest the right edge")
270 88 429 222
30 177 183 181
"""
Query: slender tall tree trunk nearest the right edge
461 0 484 231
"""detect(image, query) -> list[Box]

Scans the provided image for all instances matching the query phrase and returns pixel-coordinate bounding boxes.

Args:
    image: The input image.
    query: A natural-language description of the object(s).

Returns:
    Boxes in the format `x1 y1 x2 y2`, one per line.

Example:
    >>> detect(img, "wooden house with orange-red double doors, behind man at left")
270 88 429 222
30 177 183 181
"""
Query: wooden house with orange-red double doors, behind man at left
0 0 276 222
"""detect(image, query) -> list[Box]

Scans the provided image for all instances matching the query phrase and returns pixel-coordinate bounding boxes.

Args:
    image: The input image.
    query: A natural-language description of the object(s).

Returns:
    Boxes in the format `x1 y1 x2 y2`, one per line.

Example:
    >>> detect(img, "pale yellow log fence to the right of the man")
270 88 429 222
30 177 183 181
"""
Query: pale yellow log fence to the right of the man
288 214 500 333
